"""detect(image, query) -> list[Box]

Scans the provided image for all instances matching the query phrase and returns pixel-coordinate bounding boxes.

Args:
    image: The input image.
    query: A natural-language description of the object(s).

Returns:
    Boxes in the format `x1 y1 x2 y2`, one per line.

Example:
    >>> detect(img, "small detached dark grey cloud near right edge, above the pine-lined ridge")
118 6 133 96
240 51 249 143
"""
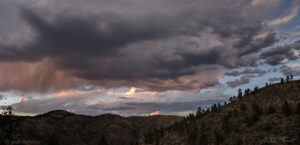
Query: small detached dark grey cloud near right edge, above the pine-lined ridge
260 45 297 66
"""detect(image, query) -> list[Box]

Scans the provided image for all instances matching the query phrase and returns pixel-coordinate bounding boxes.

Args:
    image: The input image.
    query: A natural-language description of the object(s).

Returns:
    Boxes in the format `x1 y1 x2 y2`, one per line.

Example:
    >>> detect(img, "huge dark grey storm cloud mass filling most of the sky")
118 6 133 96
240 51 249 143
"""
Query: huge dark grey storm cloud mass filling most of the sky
0 0 282 91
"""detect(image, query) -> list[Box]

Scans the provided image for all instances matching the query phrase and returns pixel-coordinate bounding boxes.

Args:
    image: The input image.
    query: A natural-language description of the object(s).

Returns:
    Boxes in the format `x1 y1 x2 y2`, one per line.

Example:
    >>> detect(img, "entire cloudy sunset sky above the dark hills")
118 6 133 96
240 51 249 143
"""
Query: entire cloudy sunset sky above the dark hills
0 0 300 116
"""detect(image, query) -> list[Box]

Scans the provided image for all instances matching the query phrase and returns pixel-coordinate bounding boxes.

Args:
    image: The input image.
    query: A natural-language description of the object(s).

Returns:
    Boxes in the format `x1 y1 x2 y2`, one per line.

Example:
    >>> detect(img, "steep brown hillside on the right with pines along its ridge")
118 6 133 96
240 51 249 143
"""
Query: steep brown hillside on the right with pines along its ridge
148 81 300 145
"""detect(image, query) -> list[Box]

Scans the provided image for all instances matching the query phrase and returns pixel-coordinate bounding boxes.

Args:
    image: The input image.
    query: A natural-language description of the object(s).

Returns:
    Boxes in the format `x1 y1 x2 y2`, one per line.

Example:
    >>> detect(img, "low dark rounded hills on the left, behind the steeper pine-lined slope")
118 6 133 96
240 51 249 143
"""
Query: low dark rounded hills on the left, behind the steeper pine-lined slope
0 110 182 145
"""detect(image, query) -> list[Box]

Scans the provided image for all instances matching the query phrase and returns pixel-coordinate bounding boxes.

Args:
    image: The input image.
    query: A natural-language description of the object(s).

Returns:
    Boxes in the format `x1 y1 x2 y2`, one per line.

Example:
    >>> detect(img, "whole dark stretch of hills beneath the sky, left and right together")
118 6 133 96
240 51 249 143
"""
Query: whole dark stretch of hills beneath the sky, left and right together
0 81 300 145
